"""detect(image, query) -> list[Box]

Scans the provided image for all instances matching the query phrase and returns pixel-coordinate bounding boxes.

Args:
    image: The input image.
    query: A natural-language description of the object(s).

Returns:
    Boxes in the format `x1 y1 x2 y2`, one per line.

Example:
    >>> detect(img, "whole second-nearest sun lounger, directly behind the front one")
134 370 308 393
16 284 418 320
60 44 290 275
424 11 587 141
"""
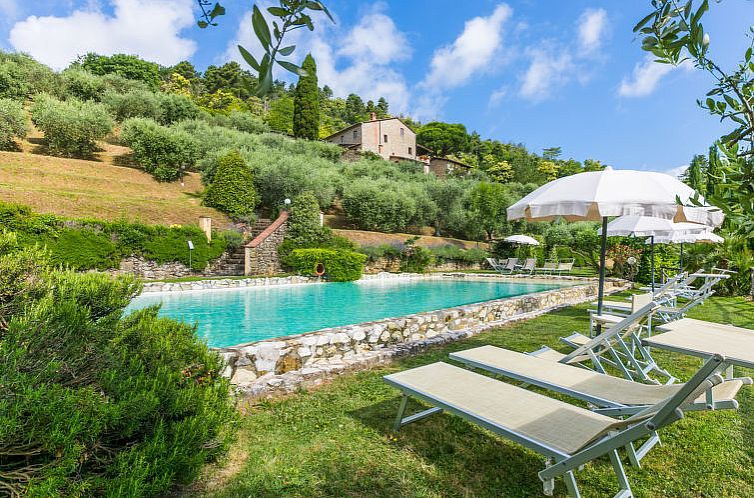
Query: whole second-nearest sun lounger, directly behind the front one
450 346 752 467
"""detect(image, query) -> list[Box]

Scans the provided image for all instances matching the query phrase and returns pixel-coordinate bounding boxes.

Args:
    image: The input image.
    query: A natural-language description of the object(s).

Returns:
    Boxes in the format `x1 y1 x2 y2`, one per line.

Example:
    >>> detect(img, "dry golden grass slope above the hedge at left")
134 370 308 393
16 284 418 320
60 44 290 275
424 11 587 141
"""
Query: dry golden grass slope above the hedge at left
0 148 229 225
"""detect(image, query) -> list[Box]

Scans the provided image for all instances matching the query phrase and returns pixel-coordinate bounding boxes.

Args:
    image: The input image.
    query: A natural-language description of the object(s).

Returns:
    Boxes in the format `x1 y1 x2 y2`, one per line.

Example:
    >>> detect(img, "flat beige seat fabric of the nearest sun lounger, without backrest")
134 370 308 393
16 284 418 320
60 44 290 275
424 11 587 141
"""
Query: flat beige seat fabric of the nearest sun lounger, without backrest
386 362 615 454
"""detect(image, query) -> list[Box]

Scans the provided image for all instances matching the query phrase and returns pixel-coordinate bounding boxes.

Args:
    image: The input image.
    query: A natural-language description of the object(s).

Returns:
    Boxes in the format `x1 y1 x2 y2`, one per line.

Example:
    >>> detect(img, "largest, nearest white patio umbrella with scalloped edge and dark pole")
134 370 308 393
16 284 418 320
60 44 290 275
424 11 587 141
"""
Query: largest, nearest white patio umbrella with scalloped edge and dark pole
508 167 724 313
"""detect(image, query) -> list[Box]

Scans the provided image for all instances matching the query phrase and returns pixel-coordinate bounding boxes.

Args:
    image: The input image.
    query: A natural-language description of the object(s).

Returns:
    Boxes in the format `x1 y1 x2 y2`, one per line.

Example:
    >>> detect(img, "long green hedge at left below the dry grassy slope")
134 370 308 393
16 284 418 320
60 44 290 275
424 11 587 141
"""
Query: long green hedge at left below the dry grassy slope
0 202 227 271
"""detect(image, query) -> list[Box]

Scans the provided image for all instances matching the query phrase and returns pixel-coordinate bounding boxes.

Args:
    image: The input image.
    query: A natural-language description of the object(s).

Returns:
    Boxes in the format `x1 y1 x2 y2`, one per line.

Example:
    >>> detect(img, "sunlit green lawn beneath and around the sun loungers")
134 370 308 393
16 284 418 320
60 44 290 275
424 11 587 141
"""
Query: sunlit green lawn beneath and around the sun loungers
190 298 754 498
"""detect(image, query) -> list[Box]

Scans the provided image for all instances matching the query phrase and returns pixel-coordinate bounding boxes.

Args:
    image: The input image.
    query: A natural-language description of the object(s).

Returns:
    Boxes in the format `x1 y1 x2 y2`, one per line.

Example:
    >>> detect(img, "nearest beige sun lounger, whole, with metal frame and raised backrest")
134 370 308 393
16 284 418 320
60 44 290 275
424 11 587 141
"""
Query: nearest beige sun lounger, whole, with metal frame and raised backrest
384 356 724 498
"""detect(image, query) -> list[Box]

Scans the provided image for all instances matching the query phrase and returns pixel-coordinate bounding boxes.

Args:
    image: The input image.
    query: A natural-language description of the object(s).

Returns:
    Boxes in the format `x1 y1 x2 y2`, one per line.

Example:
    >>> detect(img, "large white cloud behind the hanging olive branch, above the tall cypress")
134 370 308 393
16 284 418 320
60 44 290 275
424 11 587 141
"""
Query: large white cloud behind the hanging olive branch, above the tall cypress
225 5 412 113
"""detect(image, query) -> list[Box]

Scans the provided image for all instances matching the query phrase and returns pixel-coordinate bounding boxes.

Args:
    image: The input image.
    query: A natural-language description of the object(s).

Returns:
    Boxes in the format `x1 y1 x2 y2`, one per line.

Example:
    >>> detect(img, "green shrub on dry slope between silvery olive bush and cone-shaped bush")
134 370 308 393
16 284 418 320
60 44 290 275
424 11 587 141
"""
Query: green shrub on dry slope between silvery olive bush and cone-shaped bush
120 118 198 182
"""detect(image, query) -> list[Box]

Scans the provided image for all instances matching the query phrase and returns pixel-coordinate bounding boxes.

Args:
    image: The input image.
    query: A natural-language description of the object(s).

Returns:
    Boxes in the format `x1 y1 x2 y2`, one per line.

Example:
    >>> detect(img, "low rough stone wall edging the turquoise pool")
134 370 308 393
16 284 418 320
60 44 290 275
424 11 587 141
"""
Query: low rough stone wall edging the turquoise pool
206 274 631 399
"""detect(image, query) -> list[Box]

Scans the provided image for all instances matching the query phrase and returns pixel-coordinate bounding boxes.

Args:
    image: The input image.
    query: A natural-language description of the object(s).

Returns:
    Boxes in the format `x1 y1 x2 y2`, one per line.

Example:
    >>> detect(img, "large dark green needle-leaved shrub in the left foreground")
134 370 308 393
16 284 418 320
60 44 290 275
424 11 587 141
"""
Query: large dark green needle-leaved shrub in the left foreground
0 239 236 497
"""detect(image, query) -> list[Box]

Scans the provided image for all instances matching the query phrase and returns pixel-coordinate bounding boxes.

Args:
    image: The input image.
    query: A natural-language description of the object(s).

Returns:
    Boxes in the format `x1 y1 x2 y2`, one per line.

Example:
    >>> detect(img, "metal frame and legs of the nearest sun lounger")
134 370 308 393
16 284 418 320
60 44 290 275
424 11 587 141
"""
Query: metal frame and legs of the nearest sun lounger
384 355 725 498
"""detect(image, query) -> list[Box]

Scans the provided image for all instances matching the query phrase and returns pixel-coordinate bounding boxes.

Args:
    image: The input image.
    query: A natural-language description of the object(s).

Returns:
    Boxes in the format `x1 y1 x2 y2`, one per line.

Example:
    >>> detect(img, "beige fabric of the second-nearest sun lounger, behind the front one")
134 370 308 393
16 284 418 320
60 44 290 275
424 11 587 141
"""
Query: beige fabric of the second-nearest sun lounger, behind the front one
453 346 743 406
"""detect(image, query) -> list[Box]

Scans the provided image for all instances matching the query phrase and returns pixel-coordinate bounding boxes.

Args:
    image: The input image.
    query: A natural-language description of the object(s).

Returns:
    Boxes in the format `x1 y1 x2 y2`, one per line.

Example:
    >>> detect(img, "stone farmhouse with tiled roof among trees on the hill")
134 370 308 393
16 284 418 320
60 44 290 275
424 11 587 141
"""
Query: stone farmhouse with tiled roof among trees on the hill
324 113 470 177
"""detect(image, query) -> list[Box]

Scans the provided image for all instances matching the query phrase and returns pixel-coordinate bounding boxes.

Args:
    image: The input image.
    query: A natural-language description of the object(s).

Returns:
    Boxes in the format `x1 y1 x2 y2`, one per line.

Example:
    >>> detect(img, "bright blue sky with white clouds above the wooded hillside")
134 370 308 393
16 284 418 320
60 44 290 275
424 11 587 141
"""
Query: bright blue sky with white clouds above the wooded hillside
0 0 754 172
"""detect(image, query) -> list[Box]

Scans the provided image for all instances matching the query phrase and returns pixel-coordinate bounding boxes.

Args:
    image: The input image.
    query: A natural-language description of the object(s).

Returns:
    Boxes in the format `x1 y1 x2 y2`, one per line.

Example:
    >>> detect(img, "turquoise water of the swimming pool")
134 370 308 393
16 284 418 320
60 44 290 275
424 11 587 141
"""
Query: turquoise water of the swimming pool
128 279 562 347
